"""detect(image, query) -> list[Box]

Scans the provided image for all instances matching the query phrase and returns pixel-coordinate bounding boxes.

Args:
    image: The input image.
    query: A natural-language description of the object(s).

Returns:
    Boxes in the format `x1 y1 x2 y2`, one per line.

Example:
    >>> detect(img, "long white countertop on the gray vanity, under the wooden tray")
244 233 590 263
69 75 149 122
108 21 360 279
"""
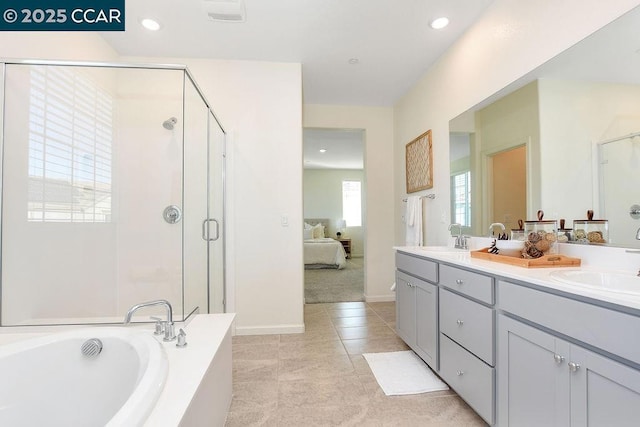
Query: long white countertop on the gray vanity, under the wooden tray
394 245 640 315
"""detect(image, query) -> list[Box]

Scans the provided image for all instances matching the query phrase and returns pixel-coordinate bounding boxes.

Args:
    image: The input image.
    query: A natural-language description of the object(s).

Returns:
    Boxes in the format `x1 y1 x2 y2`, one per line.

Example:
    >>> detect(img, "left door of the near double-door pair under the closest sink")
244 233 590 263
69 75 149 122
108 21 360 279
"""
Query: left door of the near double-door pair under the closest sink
496 315 571 427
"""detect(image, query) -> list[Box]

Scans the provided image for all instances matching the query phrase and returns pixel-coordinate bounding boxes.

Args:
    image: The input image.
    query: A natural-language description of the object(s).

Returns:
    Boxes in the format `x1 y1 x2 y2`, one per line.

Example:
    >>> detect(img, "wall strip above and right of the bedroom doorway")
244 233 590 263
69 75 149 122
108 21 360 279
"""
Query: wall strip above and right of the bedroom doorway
304 104 402 301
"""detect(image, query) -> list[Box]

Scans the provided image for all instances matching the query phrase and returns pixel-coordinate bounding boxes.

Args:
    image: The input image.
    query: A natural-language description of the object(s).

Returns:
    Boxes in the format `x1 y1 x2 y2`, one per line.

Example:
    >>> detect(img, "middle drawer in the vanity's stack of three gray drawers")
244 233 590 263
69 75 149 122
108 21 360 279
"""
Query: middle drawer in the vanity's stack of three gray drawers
440 289 495 366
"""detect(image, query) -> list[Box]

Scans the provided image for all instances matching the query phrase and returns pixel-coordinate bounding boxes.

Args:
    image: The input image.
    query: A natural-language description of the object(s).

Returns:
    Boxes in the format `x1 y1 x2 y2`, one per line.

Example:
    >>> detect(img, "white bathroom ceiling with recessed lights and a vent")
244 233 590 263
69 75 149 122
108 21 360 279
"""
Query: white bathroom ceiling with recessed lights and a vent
100 0 491 106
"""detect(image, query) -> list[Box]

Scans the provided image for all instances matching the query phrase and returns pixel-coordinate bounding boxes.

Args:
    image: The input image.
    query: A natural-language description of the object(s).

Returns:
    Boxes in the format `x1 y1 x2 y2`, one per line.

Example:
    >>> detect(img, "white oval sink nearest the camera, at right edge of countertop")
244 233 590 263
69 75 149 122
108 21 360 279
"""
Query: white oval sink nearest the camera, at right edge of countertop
549 270 640 295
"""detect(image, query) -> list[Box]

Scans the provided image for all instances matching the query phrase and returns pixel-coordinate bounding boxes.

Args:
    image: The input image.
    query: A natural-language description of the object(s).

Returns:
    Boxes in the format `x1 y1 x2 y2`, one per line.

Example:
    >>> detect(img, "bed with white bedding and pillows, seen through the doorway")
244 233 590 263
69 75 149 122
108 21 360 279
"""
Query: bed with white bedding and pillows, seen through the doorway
304 218 347 269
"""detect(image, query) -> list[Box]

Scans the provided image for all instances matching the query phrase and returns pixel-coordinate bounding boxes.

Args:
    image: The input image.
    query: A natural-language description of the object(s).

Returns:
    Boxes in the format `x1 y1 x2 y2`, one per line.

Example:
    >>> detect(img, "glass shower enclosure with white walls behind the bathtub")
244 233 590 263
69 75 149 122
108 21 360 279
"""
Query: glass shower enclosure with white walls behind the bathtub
0 61 225 326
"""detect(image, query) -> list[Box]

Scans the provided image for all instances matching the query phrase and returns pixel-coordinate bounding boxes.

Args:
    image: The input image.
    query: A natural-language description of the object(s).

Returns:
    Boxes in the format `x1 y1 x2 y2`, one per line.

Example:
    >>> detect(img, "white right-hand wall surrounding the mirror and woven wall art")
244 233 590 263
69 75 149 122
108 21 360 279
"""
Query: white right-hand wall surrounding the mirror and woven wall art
394 0 640 244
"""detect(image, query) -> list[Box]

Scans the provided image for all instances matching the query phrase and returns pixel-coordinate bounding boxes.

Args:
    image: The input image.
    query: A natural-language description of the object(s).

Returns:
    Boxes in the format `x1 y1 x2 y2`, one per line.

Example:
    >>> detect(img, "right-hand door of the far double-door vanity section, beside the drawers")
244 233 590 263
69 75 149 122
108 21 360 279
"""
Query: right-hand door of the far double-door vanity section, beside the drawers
415 282 439 370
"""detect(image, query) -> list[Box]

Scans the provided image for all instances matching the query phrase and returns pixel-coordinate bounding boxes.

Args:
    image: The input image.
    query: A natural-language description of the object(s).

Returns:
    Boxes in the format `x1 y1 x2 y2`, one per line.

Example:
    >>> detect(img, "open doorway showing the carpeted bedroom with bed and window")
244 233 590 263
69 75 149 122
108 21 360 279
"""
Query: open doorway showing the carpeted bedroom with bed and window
303 128 366 303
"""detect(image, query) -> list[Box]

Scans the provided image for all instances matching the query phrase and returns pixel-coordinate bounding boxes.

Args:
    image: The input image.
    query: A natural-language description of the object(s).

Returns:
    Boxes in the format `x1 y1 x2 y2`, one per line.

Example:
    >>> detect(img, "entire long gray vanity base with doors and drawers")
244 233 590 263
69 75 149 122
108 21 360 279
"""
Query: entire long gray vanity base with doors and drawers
396 247 640 427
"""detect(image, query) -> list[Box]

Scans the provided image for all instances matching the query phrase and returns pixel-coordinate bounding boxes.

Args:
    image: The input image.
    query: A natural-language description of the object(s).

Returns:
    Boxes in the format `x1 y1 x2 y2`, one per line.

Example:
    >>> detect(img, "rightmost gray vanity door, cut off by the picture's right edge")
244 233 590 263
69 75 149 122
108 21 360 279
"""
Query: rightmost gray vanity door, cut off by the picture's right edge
571 346 640 427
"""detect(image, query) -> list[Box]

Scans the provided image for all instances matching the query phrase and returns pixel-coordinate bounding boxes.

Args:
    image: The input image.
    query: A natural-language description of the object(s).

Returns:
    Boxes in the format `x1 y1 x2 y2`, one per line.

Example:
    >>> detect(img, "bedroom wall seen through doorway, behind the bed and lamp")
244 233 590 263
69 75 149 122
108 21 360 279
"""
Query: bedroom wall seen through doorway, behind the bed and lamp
303 169 367 257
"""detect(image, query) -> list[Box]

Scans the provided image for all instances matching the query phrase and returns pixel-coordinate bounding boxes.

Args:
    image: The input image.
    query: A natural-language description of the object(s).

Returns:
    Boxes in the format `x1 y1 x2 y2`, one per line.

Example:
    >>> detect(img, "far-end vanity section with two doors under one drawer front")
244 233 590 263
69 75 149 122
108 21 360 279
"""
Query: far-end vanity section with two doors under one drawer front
396 253 438 370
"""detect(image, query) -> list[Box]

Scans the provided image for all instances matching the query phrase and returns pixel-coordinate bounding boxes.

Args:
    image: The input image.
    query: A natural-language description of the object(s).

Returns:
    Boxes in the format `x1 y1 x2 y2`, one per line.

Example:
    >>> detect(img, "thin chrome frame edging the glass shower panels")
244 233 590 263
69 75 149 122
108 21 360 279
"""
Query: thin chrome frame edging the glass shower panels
0 58 227 326
